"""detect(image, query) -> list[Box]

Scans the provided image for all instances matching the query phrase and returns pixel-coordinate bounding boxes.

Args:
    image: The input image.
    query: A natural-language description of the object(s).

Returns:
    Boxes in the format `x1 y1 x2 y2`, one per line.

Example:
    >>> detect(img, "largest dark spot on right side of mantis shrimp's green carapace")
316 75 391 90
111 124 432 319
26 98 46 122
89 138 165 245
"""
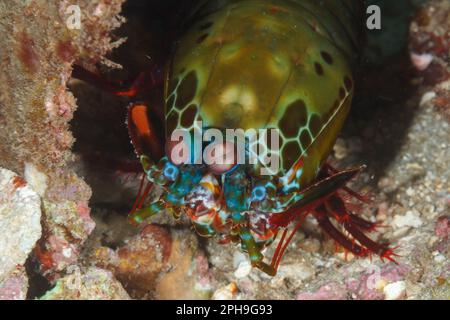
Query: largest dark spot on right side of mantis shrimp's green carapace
279 99 308 138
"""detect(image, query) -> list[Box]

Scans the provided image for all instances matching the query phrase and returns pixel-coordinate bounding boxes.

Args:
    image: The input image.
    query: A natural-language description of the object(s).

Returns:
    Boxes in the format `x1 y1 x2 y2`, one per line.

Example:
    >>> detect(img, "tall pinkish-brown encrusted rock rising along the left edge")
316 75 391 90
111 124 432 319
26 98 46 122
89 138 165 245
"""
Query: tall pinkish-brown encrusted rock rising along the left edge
0 0 123 279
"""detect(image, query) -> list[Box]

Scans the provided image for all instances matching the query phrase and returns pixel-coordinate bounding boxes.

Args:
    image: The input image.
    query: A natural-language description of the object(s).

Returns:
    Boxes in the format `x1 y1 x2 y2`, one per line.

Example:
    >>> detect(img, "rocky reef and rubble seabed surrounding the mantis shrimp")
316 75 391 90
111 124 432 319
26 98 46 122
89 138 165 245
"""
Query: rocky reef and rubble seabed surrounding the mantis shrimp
0 0 450 300
